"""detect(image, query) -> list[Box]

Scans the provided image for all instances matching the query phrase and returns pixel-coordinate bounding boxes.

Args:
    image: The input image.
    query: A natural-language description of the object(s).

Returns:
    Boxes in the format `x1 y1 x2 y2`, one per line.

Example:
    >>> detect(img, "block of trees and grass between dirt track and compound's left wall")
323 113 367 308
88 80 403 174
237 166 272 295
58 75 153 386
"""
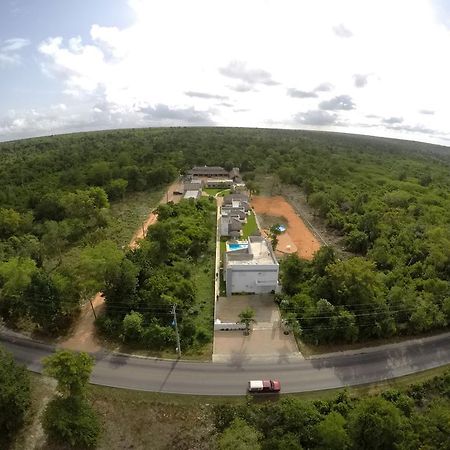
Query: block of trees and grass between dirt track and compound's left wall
97 198 216 350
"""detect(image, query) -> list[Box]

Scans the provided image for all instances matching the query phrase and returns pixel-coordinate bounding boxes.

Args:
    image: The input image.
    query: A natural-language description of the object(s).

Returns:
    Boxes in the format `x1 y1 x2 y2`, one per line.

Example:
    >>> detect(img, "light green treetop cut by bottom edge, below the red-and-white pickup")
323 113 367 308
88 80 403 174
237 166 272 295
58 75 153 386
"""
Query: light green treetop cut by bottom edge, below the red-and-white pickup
218 418 262 450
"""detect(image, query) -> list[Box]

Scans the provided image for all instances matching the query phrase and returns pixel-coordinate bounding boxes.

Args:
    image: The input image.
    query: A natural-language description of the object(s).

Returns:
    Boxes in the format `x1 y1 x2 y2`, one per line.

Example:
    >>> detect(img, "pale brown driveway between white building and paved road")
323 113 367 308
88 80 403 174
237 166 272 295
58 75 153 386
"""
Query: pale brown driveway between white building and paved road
213 295 302 366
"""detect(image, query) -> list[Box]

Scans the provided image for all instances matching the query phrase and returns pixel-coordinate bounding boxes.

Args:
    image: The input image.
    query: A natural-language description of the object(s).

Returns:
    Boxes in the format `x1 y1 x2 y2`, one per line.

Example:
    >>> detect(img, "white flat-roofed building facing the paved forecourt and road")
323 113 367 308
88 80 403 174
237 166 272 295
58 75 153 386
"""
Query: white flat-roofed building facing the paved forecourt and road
224 236 279 296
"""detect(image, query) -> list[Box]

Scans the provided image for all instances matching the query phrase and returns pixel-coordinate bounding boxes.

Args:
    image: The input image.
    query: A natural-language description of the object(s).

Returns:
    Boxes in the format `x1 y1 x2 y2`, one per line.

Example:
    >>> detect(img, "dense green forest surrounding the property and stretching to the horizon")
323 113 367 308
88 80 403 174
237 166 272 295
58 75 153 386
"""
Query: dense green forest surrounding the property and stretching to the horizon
0 128 450 346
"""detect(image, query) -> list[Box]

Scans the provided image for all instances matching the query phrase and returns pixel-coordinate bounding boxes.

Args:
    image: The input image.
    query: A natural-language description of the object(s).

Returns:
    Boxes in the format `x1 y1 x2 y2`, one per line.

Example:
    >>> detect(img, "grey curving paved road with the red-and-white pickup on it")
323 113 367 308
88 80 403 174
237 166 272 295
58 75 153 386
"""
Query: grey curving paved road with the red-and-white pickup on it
0 333 450 395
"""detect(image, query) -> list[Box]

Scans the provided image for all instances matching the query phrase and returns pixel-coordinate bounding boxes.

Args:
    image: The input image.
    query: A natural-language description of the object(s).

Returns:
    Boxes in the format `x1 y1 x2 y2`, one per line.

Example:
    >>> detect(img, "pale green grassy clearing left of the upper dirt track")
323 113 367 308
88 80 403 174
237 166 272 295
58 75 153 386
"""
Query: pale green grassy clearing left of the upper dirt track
106 187 167 246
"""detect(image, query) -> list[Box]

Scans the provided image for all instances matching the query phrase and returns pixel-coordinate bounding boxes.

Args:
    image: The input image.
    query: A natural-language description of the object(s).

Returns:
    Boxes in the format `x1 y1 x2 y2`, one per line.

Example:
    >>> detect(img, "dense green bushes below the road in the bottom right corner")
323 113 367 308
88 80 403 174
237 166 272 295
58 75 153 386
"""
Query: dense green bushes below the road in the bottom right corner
214 371 450 450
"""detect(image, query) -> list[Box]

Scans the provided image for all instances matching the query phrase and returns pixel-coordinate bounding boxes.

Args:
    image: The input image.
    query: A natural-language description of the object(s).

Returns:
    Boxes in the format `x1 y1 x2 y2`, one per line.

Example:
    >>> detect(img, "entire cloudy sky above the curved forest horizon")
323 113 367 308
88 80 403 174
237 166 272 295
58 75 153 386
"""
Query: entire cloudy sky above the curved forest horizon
0 0 450 145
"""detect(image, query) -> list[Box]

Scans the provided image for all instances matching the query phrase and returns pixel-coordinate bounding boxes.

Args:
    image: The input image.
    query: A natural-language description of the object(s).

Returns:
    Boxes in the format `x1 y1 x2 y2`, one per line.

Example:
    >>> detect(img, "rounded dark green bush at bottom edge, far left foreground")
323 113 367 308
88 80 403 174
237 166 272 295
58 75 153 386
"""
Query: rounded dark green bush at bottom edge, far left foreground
42 397 100 449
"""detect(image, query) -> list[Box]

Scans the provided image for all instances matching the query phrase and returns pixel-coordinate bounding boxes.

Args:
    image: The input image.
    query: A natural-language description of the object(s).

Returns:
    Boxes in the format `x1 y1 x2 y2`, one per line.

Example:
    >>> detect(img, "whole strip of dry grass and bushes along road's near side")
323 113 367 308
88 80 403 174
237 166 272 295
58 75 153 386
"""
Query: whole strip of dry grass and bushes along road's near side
5 352 450 450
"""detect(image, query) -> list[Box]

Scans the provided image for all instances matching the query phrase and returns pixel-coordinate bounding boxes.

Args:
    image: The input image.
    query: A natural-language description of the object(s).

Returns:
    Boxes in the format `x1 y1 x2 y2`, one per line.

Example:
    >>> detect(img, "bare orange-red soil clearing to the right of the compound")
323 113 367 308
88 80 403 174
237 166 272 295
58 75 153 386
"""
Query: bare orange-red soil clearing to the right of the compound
252 196 320 259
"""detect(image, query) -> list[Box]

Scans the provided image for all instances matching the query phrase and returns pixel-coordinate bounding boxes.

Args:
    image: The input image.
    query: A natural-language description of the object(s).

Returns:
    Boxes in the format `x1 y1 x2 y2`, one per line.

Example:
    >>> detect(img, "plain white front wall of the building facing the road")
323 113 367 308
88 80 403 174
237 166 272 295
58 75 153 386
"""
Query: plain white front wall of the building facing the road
226 265 278 295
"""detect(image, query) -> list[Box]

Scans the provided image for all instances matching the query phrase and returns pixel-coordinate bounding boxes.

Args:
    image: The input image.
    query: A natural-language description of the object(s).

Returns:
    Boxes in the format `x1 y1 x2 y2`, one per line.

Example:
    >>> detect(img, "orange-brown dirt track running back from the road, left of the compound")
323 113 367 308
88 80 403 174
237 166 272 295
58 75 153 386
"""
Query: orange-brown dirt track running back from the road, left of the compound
59 181 182 352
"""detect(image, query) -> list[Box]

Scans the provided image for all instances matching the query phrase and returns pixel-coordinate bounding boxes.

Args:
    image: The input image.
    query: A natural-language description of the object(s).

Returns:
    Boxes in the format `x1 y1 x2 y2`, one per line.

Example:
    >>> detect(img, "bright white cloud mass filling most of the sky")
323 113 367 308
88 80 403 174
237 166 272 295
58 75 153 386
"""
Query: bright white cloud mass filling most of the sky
0 0 450 141
